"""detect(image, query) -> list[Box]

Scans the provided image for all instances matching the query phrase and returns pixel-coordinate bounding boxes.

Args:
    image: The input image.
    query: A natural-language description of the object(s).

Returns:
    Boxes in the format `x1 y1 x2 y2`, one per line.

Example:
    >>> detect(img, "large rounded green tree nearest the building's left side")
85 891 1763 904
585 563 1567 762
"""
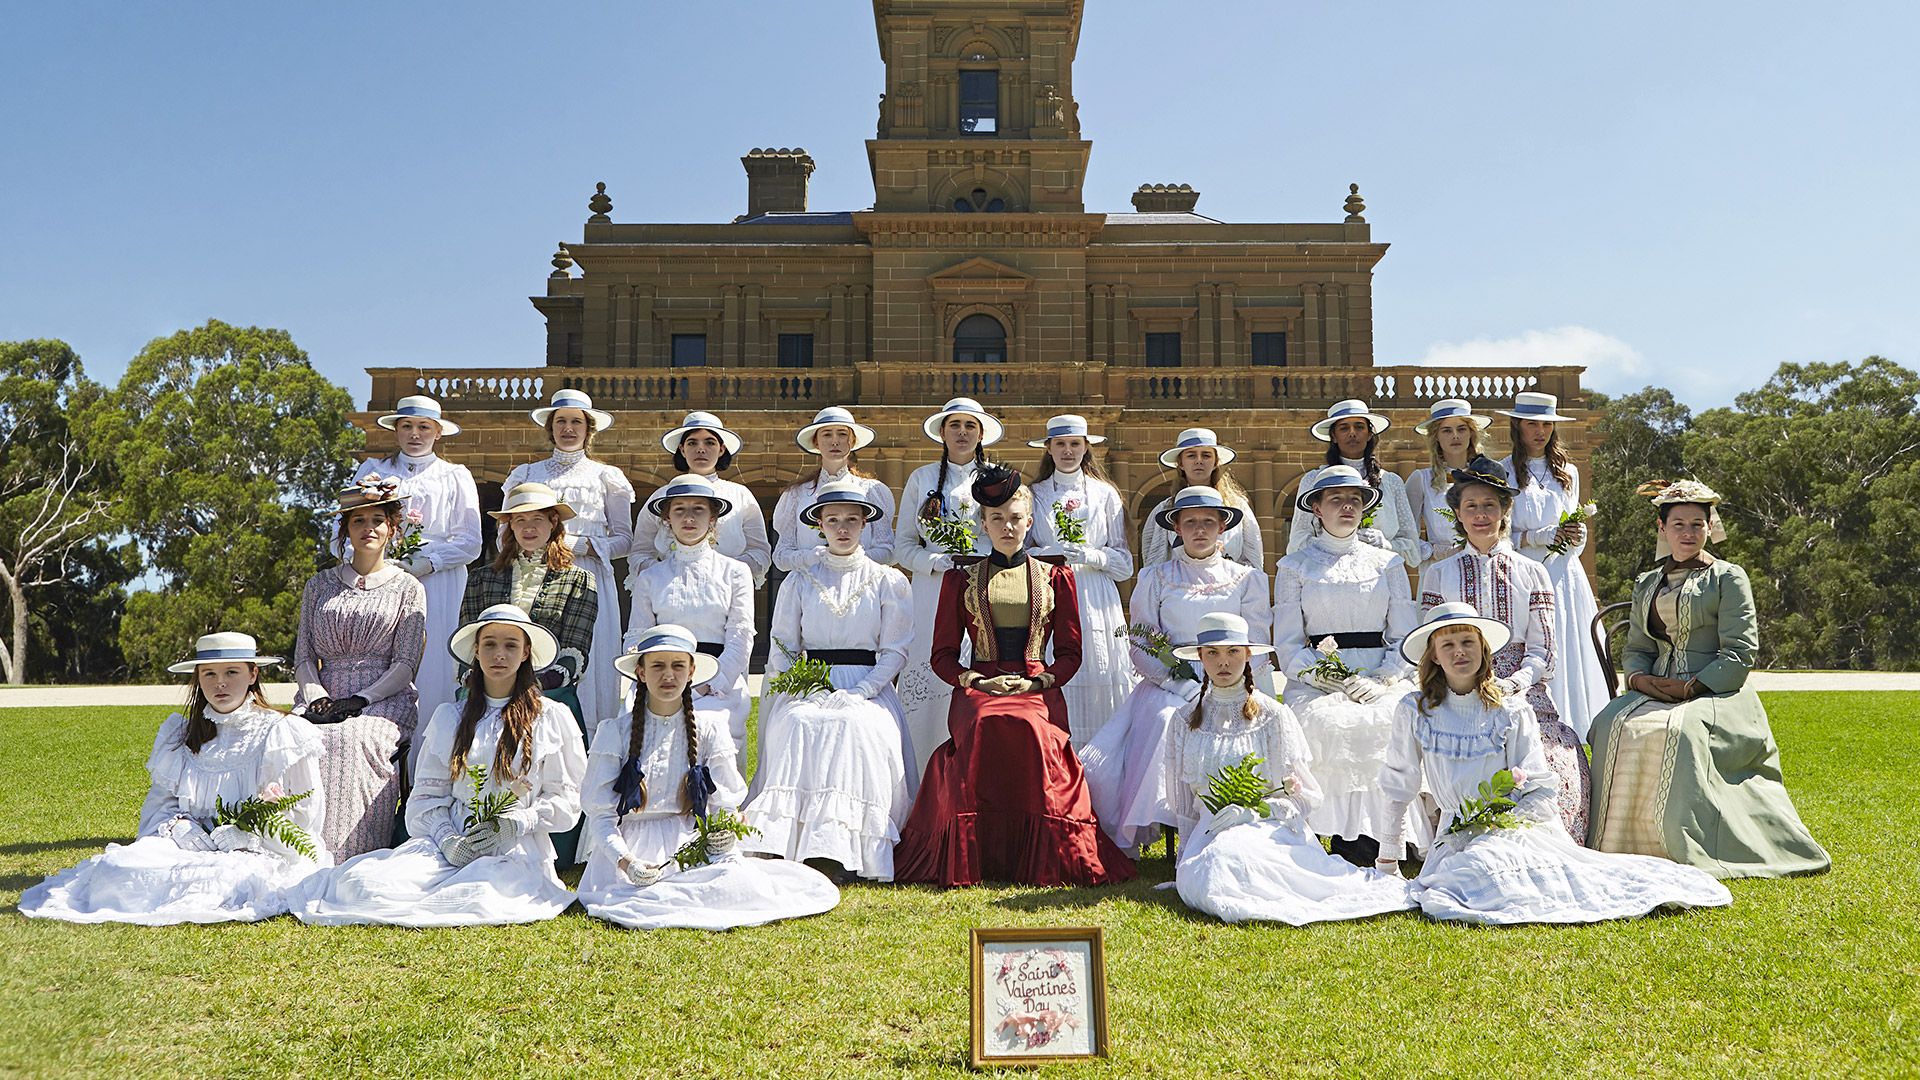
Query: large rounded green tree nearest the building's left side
96 321 363 675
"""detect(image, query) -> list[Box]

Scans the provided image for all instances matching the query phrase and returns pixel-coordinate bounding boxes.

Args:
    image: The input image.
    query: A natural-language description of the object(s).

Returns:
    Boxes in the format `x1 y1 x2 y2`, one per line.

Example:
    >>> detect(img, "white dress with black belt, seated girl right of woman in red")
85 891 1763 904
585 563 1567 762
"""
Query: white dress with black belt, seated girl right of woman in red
1273 532 1432 847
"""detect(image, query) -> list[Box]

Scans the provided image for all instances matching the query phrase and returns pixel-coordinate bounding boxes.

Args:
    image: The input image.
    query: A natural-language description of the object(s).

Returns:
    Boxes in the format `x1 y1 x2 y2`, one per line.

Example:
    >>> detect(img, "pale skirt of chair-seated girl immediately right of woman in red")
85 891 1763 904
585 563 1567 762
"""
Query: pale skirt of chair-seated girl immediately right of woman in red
1081 682 1200 851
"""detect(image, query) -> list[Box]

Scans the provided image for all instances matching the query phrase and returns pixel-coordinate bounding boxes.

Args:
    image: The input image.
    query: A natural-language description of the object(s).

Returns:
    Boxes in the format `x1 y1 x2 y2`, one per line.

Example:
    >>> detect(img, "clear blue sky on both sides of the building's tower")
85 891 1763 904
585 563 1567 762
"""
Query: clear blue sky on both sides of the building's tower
0 0 1920 407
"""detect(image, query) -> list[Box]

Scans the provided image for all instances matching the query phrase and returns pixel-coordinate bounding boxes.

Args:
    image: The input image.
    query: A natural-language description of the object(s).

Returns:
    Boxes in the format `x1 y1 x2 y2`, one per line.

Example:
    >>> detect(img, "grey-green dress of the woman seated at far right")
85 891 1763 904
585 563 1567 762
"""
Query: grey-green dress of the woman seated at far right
1588 555 1828 878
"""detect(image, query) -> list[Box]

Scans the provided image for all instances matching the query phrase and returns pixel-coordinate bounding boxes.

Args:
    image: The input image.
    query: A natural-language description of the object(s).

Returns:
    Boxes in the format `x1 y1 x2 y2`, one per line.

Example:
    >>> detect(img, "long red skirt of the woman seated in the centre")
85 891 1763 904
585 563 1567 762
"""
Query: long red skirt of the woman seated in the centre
893 688 1139 886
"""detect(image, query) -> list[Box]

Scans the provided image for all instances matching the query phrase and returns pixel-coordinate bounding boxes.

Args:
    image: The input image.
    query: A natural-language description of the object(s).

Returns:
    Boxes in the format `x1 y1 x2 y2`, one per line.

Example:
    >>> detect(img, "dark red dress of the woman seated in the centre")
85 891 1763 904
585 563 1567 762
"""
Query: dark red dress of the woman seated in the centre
893 559 1137 886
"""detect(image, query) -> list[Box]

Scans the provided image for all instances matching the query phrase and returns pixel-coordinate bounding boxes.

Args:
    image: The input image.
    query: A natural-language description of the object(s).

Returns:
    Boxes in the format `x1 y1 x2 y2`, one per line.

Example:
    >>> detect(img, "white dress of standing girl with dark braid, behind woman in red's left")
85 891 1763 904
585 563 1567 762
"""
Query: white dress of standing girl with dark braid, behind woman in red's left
893 453 993 776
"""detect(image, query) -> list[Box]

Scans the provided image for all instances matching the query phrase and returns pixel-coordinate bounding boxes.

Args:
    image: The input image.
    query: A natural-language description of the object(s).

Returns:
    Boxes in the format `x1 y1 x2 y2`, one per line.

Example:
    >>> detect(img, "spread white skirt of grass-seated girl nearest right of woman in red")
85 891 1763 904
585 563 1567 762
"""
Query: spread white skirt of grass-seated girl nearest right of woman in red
1173 807 1419 926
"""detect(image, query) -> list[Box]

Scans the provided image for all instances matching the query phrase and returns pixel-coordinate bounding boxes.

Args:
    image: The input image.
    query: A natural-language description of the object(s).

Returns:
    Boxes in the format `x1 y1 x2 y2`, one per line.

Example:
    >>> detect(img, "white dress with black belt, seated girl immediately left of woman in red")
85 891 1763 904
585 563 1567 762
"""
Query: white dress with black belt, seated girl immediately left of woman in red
741 552 914 880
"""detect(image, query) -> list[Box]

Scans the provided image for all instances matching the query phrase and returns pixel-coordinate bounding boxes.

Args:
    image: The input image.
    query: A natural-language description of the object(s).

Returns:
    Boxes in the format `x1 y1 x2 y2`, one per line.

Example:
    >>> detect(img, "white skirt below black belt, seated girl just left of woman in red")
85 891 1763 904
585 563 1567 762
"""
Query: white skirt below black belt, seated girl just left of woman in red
739 690 912 882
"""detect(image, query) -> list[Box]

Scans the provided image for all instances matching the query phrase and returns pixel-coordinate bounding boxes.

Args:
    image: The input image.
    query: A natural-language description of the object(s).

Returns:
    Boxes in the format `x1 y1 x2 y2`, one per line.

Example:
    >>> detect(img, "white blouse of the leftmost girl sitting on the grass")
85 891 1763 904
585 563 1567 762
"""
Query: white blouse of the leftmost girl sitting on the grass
140 701 326 841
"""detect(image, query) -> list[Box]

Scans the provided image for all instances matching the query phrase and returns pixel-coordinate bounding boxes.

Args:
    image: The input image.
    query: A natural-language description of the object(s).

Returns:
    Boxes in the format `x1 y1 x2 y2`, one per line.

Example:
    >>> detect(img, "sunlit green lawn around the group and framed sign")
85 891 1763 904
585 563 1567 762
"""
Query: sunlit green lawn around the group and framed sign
0 694 1920 1078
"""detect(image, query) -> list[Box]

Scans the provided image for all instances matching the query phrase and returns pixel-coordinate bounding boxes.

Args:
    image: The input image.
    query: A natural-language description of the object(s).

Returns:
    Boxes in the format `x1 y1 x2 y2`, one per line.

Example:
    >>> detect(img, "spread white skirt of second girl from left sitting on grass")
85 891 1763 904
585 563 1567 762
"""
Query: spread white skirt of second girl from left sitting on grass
294 836 574 926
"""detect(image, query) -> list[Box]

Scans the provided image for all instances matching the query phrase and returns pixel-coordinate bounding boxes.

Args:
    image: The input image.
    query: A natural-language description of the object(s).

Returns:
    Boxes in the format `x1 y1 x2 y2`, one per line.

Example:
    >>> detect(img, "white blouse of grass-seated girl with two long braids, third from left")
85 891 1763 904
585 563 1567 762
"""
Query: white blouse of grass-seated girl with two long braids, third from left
582 707 747 861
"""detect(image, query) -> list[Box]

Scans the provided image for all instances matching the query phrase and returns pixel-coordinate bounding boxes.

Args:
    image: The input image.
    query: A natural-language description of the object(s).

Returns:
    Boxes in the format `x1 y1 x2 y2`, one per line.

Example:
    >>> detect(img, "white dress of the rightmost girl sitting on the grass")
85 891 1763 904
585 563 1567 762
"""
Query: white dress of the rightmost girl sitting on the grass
1380 694 1734 926
